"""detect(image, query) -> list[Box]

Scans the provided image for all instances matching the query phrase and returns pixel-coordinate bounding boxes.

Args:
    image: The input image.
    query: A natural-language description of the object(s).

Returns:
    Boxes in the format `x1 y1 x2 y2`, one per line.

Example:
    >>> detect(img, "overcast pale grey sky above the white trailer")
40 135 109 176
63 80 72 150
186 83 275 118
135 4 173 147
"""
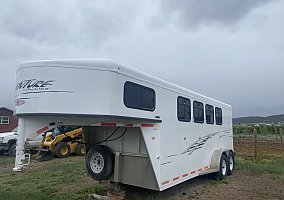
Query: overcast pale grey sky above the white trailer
0 0 284 117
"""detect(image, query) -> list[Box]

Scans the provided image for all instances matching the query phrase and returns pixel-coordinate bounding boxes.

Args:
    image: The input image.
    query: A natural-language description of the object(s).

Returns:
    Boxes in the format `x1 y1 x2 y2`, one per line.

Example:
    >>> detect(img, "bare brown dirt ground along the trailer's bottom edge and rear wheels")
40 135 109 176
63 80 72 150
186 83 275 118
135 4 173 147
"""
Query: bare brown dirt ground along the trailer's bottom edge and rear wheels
126 170 284 200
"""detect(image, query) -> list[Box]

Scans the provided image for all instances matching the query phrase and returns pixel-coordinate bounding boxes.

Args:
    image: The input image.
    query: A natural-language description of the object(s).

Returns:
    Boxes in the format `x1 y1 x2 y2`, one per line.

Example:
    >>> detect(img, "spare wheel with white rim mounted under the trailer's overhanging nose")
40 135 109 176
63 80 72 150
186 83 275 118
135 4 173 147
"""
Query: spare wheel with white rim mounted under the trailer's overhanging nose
86 145 114 181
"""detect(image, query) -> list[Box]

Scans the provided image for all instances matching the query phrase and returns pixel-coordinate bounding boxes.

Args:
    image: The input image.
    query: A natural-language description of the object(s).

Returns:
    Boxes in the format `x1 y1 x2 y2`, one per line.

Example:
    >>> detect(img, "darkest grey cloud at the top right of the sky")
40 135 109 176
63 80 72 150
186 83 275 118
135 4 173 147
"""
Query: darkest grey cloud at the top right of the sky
161 0 273 29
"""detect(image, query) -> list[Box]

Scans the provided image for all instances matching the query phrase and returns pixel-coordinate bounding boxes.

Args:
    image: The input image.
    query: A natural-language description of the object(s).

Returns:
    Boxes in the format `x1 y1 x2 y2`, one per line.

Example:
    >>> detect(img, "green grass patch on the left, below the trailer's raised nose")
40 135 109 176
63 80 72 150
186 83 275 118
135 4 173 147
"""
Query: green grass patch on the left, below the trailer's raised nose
0 156 102 200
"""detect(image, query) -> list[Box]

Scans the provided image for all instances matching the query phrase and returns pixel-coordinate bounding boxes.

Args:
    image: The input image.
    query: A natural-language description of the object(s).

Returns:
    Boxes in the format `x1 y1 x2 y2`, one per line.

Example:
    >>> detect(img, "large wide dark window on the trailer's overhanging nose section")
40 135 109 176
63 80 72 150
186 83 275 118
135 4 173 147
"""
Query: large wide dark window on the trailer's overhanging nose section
123 81 156 111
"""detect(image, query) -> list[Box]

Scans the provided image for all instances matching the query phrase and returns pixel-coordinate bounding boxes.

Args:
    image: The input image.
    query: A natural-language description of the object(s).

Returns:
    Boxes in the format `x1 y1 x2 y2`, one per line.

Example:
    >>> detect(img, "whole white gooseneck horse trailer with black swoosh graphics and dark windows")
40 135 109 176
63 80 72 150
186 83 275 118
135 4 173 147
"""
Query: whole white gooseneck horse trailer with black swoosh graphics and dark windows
14 59 234 191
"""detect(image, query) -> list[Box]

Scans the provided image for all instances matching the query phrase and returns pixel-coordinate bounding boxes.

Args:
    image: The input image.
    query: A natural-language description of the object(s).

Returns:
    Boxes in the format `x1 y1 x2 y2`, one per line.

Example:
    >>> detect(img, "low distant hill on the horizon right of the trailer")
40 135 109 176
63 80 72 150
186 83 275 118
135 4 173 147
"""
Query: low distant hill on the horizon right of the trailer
233 114 284 124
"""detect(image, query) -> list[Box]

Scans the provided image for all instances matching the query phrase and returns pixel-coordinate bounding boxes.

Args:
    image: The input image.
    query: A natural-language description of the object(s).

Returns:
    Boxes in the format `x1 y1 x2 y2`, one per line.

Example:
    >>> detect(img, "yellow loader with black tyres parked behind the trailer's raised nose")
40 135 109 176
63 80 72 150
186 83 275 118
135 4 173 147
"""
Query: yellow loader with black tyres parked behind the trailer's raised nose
39 126 85 160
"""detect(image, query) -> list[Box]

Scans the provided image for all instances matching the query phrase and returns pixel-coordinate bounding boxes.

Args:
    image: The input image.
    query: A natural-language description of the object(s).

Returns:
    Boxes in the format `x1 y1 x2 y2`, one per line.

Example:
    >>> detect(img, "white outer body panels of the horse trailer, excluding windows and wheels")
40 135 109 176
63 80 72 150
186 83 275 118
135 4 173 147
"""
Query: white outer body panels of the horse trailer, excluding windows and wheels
15 60 233 190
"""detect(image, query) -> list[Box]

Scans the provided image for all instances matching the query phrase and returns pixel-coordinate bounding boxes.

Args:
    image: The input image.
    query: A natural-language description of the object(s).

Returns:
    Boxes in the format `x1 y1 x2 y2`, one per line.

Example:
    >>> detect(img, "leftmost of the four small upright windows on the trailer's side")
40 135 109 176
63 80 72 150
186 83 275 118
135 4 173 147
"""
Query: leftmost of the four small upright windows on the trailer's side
177 96 191 122
